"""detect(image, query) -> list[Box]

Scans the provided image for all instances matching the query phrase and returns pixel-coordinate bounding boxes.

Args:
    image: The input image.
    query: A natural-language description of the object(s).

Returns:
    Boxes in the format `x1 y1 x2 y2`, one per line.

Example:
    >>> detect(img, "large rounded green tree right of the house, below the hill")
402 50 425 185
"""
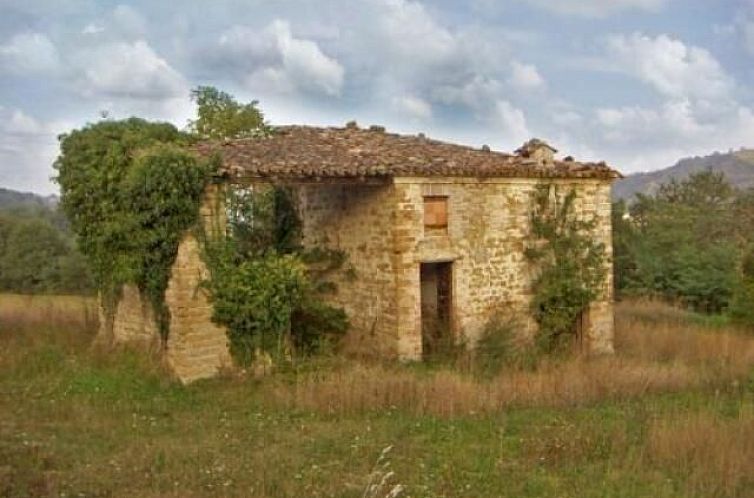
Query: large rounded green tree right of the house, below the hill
614 171 741 312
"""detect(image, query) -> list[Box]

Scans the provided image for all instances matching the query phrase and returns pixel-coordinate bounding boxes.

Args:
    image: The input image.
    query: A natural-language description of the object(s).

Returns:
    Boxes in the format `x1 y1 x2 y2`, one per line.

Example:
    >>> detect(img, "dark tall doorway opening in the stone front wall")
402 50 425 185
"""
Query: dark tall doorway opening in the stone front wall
420 262 453 357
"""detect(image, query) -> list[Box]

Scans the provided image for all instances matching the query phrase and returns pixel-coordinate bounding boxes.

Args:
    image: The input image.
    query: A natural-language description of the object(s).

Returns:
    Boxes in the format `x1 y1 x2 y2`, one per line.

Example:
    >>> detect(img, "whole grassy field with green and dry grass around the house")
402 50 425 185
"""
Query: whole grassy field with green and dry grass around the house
0 296 754 497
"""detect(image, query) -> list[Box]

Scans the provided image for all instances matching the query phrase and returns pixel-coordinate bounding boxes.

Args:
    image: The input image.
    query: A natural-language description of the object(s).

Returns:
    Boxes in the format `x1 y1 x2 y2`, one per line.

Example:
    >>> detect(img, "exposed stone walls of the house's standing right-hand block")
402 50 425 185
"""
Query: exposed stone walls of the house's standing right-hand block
299 178 613 359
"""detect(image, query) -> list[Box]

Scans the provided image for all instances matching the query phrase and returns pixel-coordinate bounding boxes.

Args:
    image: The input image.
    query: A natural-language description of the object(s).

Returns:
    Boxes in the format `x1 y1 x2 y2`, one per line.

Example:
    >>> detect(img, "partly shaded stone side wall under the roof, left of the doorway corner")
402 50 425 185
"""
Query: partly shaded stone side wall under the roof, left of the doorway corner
296 185 398 356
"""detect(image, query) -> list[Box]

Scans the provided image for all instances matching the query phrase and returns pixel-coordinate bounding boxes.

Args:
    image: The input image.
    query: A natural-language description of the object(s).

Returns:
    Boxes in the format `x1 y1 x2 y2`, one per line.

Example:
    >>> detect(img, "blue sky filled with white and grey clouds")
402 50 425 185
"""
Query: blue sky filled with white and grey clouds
0 0 754 194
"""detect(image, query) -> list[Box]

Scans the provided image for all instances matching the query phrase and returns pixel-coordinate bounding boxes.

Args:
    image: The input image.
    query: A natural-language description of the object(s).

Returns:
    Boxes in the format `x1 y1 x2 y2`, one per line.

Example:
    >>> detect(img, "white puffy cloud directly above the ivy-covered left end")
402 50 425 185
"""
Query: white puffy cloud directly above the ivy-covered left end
77 40 188 100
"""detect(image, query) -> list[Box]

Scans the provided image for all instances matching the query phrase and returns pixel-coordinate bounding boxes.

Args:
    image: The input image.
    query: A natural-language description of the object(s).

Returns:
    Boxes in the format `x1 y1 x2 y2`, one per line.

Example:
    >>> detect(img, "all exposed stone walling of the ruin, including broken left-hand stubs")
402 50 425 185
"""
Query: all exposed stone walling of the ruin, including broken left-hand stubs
95 178 613 382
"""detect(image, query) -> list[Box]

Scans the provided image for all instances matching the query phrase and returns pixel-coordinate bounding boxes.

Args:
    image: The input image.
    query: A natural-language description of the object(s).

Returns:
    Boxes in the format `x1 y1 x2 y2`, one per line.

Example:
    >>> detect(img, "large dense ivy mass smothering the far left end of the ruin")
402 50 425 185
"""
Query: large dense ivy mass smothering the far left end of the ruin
54 118 212 339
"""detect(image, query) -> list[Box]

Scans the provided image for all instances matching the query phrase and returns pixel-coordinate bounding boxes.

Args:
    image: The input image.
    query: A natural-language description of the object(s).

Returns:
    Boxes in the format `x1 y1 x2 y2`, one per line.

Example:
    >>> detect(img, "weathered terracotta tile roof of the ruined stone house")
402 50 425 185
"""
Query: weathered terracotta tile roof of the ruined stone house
196 125 620 179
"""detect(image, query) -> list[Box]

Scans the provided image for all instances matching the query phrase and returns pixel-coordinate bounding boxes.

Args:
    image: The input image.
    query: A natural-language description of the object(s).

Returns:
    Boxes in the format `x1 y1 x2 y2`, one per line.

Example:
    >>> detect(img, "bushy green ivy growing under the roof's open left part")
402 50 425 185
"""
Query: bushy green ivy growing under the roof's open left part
206 187 348 364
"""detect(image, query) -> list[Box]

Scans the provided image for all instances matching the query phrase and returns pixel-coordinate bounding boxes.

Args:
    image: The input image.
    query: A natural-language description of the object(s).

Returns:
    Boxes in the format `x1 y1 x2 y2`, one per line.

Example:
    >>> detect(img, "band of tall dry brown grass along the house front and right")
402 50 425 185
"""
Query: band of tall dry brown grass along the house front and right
262 302 754 417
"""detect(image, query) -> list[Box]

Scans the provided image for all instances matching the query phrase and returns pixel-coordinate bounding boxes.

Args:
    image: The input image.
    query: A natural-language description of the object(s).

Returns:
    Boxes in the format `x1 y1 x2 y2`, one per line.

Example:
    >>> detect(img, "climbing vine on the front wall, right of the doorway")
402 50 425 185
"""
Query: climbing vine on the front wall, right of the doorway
526 185 605 352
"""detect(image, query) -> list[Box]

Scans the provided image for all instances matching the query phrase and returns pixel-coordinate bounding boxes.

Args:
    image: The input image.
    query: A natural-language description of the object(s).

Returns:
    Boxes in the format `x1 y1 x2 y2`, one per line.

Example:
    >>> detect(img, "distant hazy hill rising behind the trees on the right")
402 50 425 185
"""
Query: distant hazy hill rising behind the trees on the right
613 149 754 200
